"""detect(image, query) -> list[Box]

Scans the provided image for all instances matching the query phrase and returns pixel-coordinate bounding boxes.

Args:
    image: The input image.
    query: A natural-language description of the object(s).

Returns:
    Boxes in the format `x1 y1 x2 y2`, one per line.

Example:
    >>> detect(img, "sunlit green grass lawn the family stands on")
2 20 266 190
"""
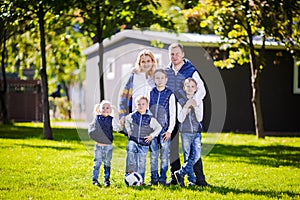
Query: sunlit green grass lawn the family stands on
0 123 300 200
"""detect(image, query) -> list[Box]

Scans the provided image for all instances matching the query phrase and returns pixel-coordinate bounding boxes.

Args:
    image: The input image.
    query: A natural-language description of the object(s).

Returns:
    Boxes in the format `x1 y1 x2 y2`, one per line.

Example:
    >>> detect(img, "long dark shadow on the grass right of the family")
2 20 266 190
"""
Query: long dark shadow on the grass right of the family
204 144 300 168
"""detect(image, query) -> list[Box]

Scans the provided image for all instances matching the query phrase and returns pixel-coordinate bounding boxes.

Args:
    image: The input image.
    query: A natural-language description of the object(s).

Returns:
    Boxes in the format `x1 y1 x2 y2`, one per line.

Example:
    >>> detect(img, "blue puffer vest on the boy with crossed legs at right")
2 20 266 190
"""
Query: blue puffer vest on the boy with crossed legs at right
179 98 202 133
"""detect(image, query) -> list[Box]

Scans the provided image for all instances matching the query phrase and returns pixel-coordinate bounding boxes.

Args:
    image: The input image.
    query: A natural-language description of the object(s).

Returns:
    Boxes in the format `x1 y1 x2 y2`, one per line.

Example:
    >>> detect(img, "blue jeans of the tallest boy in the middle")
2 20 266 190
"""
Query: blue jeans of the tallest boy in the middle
150 133 170 183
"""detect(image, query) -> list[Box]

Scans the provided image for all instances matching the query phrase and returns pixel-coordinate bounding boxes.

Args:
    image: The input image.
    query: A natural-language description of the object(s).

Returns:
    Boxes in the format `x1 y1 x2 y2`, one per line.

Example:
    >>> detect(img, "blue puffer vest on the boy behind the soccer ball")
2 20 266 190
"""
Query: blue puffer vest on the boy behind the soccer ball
129 110 153 146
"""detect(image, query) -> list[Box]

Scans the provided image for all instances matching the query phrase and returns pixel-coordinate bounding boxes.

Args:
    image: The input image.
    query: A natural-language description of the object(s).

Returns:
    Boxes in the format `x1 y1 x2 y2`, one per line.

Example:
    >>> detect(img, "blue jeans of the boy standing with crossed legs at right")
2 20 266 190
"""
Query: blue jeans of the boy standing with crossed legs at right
180 133 201 183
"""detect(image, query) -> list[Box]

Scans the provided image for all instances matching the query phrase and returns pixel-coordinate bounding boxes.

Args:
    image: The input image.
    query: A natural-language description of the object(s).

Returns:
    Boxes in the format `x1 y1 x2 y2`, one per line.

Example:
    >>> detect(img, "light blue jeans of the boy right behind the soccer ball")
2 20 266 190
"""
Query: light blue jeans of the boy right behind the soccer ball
126 140 149 180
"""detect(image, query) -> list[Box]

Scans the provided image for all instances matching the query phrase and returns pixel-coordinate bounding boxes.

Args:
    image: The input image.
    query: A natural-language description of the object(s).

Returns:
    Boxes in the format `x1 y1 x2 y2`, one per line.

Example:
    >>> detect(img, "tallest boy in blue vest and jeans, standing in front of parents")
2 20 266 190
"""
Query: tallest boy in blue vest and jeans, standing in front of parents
148 69 176 186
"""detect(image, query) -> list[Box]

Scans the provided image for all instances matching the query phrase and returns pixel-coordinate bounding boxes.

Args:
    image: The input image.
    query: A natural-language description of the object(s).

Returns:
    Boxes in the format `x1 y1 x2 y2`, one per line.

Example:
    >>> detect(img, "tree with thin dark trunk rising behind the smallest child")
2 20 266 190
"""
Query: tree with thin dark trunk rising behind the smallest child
76 0 174 100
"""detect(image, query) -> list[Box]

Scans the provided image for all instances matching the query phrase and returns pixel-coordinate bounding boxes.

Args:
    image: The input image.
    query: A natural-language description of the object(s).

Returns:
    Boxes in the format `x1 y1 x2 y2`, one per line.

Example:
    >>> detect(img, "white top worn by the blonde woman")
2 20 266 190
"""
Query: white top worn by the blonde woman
132 72 155 112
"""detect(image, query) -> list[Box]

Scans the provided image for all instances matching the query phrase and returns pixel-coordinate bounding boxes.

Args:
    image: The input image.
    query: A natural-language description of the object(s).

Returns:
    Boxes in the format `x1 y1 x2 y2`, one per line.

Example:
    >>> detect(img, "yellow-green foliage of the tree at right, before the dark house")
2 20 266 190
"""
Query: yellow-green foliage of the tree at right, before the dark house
180 0 300 68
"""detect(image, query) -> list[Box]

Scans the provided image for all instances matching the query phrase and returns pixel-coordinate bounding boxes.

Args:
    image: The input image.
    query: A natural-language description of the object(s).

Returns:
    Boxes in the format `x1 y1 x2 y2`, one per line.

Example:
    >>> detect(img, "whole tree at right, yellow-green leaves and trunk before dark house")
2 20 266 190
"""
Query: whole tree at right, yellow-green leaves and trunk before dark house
184 0 300 138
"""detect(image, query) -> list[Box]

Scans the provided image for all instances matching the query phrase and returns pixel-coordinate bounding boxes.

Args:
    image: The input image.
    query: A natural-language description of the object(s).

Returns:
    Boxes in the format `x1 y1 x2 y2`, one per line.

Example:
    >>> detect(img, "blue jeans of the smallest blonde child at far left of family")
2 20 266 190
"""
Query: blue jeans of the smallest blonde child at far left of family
92 144 113 179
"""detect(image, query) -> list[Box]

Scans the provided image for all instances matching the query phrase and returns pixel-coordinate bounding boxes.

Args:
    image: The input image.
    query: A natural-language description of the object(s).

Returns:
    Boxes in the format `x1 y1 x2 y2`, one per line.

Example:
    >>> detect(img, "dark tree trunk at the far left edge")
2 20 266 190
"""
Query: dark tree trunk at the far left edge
0 35 9 124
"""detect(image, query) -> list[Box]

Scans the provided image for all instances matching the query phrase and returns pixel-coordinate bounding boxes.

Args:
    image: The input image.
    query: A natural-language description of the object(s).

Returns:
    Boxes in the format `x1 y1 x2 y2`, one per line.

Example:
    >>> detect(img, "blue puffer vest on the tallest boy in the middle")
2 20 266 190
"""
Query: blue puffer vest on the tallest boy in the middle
149 87 173 131
